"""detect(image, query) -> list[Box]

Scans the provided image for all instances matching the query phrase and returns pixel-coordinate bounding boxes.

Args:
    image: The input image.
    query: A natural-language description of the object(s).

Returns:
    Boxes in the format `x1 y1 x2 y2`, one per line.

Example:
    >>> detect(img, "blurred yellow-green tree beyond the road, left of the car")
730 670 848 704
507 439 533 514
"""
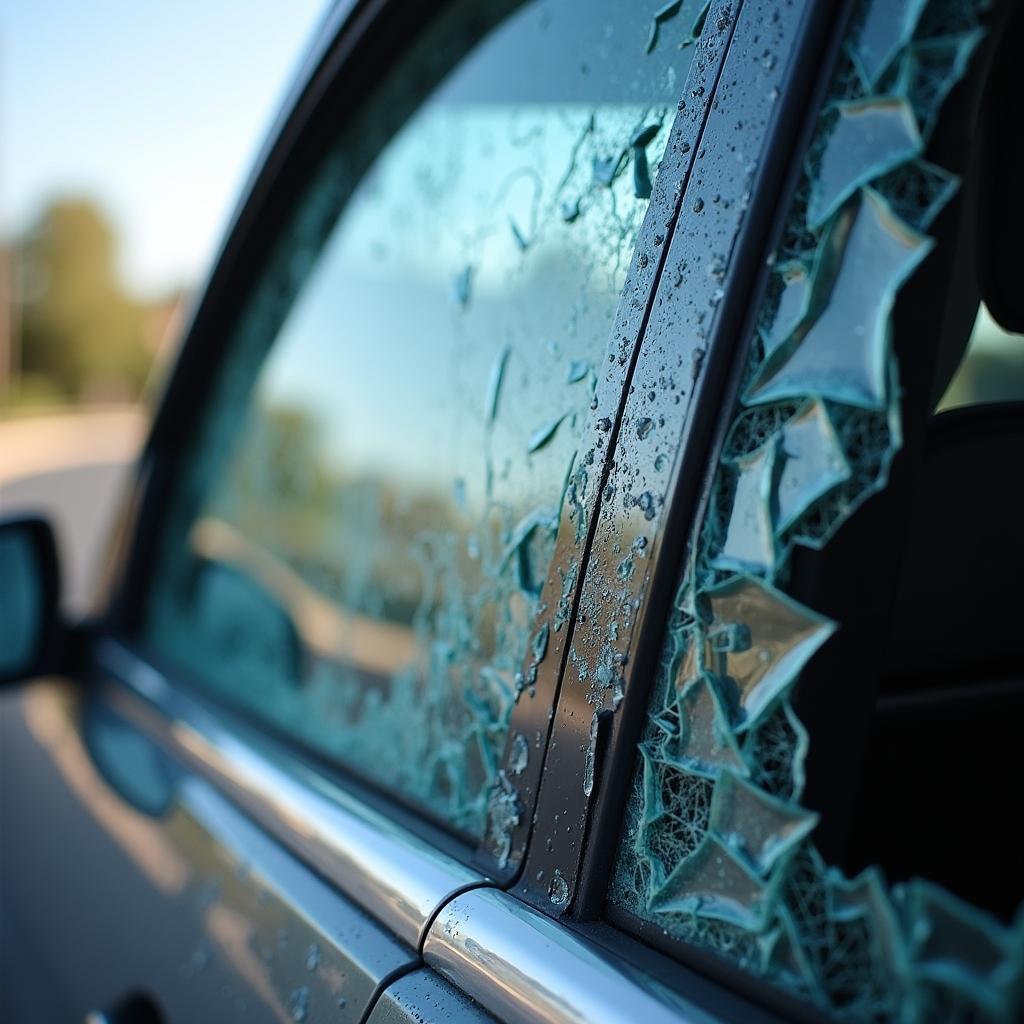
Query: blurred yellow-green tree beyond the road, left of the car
17 200 152 399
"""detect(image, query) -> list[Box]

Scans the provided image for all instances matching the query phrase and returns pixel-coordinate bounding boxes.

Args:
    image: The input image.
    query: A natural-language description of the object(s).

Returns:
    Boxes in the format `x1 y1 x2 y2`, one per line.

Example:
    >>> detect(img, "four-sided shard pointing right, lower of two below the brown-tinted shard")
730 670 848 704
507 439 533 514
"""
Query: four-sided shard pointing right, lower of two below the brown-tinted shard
710 771 818 878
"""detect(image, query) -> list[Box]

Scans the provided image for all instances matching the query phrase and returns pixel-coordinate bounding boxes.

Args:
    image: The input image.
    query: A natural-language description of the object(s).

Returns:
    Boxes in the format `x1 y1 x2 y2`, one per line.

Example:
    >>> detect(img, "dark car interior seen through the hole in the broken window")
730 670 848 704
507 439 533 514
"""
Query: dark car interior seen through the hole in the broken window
794 0 1024 920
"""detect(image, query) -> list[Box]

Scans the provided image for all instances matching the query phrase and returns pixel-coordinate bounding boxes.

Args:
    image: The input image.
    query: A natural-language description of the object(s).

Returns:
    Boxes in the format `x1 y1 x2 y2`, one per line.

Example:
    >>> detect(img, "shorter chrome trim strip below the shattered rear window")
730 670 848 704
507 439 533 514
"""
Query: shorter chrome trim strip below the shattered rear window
423 888 721 1024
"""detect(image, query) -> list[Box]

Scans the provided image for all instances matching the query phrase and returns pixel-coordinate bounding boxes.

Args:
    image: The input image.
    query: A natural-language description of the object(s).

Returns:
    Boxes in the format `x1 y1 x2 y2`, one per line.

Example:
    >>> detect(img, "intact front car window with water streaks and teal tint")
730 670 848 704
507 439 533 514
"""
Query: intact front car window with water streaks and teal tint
143 0 700 836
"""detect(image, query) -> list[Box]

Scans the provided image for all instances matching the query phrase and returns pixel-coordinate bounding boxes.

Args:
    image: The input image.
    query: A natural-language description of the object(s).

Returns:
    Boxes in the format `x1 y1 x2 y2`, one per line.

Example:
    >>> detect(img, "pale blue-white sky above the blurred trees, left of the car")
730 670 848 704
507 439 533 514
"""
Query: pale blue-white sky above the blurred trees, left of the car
0 0 329 295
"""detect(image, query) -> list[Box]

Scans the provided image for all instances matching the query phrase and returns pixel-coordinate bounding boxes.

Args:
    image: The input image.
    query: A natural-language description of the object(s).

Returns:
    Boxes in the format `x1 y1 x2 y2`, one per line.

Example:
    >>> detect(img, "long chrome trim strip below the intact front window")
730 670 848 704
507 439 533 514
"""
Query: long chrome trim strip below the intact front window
93 637 487 949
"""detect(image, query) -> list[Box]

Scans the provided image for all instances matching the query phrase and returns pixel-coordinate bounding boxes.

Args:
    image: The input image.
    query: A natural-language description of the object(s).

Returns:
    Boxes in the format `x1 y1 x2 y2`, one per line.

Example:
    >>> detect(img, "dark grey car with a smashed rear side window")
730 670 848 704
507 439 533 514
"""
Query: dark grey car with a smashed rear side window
0 0 1024 1024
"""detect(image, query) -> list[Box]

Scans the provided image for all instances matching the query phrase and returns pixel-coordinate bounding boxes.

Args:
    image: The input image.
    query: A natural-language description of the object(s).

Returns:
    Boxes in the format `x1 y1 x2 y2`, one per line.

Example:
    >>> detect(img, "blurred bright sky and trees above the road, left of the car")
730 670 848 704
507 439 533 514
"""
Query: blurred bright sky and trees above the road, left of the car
0 0 327 409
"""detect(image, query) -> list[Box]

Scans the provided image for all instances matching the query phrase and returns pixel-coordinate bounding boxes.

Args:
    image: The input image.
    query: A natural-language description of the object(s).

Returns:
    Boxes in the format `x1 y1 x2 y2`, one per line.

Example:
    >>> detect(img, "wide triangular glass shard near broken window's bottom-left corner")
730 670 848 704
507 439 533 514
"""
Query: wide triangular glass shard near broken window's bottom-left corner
650 835 775 932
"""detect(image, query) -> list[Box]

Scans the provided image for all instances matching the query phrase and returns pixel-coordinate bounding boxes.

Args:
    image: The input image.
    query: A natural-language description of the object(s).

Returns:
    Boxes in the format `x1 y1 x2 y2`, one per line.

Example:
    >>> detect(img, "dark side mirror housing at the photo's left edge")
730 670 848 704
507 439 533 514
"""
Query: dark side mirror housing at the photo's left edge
0 517 60 683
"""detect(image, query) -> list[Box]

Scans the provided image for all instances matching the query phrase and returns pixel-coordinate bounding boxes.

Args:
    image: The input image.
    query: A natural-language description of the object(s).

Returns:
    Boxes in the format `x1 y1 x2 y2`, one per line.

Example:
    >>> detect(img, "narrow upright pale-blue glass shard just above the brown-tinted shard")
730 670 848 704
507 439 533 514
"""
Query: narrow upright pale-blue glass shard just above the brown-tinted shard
713 441 778 572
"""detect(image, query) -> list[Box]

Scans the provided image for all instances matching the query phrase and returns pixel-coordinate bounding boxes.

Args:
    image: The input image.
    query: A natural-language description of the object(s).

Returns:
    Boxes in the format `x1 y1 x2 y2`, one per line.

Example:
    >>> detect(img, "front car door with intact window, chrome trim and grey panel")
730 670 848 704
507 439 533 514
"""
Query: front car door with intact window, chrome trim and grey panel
2 3 732 1021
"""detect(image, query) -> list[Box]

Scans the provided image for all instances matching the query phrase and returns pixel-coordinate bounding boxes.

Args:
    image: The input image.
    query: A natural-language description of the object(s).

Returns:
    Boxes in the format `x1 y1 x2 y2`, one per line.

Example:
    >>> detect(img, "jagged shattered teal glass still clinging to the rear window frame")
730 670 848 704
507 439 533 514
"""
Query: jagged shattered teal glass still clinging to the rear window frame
609 0 1024 1022
